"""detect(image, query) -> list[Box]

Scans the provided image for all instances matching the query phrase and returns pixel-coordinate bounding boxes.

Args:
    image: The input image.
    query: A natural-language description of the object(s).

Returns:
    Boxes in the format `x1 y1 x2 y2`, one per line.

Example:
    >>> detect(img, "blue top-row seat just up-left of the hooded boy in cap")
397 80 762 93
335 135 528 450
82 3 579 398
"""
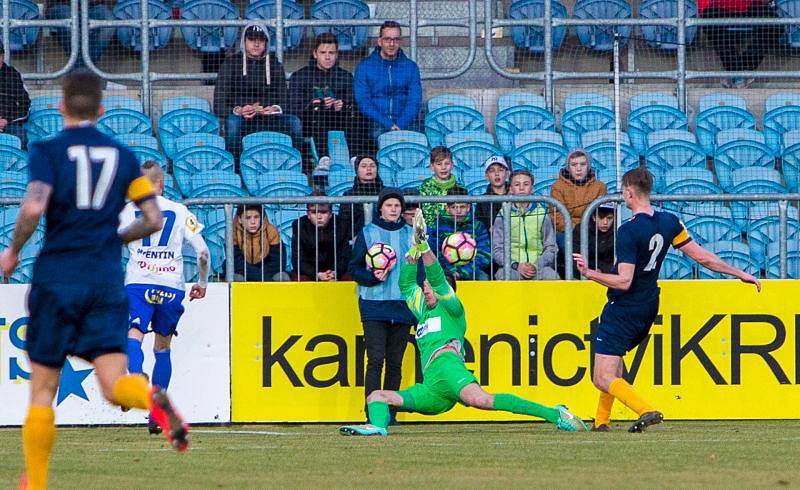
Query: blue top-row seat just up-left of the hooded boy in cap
181 0 239 53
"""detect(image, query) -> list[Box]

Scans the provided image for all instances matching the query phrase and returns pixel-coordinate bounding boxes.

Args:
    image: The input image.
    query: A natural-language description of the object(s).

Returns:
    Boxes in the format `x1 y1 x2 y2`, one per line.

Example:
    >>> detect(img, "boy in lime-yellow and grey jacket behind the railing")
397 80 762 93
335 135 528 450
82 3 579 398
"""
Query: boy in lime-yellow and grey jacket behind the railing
492 170 559 280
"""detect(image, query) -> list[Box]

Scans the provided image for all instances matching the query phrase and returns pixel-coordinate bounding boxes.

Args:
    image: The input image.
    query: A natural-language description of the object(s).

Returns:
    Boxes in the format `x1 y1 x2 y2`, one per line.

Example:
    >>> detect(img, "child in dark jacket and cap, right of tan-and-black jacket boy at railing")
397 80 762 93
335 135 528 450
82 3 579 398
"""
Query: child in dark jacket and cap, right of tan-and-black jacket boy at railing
291 192 350 281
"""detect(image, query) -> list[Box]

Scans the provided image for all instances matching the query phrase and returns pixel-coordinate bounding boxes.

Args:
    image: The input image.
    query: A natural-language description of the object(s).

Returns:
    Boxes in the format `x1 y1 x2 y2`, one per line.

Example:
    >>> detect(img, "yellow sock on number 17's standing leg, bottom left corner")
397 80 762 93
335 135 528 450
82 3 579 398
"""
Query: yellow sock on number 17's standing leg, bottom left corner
22 405 56 490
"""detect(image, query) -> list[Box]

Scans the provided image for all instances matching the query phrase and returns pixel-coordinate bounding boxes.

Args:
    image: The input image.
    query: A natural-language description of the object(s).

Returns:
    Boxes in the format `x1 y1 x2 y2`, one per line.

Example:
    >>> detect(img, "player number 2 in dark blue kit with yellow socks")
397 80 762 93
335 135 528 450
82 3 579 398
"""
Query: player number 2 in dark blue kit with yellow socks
573 167 761 432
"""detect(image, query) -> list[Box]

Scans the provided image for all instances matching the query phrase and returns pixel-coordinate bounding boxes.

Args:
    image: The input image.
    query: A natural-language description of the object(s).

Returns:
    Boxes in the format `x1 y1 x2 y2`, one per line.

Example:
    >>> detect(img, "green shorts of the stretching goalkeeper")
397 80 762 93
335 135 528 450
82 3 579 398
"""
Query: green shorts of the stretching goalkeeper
398 352 478 415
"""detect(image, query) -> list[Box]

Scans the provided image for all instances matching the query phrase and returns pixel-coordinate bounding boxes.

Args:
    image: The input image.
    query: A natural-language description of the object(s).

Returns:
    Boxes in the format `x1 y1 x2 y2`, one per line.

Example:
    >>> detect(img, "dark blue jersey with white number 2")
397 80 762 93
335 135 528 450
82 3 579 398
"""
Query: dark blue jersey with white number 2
608 210 692 304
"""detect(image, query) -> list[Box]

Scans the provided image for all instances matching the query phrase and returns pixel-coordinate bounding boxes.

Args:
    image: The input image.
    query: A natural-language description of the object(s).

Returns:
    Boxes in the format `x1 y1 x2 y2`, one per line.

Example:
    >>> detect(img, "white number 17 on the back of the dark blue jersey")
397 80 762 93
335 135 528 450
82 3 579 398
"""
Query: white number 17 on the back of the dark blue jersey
67 145 119 209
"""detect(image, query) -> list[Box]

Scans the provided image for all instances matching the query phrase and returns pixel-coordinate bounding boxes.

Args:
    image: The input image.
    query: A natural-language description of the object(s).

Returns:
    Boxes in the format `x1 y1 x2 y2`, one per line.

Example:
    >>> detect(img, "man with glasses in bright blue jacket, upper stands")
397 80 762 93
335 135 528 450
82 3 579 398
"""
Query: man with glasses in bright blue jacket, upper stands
355 20 422 152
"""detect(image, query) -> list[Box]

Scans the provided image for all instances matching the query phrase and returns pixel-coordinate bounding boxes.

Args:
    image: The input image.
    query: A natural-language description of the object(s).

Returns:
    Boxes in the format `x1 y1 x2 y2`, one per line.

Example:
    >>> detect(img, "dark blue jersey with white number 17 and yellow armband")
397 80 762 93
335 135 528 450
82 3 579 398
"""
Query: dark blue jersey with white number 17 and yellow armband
28 124 154 287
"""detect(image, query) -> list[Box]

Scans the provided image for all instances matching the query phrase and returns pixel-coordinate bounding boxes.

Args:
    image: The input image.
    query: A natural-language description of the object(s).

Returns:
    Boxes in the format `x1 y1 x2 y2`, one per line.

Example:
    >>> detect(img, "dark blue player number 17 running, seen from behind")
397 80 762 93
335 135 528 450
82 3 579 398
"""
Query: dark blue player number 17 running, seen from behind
0 70 188 489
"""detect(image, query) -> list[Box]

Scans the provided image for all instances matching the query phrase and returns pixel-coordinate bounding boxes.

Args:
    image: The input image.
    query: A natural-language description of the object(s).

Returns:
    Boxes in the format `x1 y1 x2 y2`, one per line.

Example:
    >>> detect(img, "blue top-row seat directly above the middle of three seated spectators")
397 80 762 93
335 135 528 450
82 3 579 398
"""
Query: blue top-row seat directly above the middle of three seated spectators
311 0 369 51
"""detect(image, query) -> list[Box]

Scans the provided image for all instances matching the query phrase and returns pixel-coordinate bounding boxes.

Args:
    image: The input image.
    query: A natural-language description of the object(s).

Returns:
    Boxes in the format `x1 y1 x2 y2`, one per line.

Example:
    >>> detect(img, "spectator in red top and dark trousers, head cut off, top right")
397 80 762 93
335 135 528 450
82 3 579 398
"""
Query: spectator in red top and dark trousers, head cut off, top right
697 0 783 87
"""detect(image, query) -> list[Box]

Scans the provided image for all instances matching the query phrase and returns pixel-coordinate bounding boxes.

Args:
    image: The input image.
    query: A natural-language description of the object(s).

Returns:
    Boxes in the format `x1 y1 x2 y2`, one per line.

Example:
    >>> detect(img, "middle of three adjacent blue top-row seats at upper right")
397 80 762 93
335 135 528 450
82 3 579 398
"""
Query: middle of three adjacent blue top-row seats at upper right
572 0 632 51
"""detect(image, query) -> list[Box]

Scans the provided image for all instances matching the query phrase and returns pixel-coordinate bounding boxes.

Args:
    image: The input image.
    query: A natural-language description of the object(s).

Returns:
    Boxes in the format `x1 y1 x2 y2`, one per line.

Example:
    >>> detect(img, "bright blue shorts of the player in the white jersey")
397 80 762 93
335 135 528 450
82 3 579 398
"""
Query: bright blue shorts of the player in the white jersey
125 284 185 337
